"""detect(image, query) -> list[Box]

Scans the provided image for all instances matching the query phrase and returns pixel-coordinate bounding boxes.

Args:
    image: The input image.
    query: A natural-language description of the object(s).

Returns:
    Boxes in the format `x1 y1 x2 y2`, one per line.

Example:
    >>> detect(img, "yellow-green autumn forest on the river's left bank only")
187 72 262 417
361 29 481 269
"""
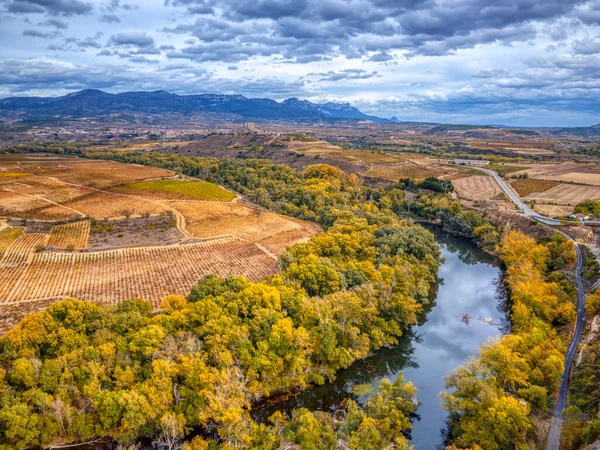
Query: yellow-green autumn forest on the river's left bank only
0 149 440 449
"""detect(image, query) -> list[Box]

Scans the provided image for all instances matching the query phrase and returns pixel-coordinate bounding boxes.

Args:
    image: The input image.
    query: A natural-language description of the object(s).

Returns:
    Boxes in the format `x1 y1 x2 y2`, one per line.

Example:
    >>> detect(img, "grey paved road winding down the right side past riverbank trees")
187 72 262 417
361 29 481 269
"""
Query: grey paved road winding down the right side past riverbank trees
464 167 584 450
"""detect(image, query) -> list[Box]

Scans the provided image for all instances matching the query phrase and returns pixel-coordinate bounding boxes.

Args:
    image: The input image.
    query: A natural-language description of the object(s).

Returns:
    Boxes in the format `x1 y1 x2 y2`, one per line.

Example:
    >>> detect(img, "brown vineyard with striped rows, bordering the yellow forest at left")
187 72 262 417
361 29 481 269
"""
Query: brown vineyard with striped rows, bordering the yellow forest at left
0 234 277 307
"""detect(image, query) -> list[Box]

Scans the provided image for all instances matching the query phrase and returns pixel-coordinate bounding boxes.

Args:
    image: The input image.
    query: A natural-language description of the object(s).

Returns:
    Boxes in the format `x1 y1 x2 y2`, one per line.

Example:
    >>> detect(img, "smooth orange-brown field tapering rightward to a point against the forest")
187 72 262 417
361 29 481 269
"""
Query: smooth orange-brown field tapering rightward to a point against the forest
169 201 320 255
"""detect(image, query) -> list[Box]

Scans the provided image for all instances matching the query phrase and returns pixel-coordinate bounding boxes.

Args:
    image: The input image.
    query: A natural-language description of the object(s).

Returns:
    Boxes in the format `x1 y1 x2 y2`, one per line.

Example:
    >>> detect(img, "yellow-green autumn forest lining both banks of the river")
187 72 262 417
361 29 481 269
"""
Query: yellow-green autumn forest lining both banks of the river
0 147 588 450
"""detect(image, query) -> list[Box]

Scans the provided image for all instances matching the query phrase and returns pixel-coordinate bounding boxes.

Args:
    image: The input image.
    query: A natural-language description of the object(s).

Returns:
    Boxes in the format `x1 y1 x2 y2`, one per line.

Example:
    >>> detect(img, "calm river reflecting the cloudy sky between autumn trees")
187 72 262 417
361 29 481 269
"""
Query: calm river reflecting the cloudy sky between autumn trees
253 227 509 450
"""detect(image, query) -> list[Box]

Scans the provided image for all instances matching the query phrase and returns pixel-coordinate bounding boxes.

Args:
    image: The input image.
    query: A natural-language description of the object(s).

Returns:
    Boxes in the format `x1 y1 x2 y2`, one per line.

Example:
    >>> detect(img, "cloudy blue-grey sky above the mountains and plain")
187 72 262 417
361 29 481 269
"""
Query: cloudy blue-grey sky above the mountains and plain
0 0 600 126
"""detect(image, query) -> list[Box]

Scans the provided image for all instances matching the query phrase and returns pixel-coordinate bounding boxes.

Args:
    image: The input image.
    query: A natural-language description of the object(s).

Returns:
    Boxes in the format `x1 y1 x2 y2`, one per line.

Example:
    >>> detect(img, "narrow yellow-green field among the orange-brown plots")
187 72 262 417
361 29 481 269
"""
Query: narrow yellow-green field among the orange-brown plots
114 180 236 202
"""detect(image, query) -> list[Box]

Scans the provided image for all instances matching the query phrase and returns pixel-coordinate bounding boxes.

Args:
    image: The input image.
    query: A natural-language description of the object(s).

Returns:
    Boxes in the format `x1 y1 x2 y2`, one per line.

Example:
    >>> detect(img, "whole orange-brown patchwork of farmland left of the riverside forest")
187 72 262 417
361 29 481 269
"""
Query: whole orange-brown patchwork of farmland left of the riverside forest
0 155 320 326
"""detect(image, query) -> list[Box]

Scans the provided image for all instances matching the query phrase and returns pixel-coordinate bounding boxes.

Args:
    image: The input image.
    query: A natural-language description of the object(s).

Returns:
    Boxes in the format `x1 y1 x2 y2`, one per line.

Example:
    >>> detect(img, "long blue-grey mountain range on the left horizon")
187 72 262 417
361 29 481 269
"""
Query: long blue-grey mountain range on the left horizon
0 89 390 122
